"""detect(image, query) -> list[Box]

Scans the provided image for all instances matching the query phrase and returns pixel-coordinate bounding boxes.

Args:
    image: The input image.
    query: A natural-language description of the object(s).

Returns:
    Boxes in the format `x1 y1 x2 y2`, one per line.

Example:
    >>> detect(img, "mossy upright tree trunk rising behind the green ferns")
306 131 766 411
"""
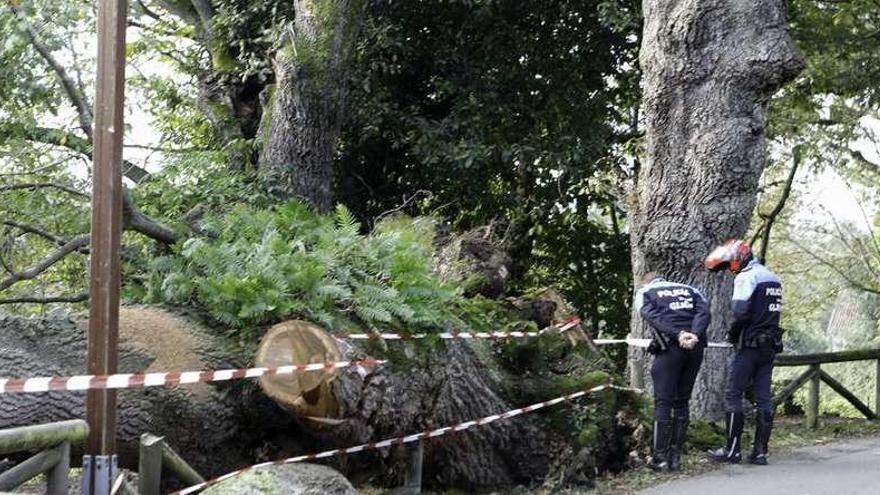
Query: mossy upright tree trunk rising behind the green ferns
260 0 364 212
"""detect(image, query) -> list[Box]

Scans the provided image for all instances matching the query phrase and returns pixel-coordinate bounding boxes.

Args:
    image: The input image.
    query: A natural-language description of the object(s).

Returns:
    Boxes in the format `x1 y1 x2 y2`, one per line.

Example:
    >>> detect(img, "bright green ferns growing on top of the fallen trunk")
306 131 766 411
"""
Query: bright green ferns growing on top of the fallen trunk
146 202 492 340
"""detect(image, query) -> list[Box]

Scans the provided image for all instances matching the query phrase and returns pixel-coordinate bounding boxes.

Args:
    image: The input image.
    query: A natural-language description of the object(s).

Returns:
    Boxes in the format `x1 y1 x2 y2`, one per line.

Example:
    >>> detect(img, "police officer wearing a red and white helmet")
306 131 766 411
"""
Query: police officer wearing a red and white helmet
705 240 782 465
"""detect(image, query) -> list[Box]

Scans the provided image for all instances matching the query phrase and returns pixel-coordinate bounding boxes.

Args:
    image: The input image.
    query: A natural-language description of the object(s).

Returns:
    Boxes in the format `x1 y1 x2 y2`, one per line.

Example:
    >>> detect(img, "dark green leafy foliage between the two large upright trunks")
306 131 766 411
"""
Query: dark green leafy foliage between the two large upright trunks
337 0 641 335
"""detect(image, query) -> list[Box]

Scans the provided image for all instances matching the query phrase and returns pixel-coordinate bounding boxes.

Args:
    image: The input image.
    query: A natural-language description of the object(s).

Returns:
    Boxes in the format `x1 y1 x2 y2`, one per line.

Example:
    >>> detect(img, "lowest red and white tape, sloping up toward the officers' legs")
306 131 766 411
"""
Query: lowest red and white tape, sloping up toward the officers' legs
172 384 638 495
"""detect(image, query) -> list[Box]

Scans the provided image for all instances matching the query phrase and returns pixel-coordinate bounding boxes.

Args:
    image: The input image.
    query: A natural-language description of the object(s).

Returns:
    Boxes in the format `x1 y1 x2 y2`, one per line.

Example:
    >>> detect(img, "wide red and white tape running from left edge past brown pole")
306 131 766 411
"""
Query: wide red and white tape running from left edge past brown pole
0 359 387 394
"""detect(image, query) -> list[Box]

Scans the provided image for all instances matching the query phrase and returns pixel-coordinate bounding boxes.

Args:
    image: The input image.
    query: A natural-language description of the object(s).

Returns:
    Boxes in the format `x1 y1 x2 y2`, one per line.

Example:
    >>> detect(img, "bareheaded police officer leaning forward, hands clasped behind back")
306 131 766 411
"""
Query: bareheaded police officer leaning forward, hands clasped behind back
635 272 711 471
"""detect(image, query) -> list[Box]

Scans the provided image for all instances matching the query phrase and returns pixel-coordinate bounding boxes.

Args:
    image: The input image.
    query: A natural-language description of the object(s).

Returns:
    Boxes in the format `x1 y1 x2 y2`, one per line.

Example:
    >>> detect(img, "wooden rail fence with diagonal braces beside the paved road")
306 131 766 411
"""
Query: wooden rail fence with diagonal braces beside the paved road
773 349 880 428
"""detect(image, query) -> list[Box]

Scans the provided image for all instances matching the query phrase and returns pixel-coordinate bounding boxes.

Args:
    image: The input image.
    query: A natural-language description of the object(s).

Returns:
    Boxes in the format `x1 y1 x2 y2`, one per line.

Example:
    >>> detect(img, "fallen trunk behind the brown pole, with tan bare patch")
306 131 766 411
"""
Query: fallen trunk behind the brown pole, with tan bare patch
0 307 293 476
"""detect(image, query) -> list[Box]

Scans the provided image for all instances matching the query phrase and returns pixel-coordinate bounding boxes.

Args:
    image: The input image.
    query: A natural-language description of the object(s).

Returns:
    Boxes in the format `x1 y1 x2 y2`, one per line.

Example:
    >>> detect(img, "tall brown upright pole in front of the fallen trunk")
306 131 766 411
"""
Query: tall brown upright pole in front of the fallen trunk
84 0 128 495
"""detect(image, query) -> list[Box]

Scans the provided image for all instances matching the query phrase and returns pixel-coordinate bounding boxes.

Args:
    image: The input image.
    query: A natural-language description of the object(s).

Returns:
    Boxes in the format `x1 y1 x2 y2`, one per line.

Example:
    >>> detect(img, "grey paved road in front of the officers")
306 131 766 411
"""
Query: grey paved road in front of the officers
639 437 880 495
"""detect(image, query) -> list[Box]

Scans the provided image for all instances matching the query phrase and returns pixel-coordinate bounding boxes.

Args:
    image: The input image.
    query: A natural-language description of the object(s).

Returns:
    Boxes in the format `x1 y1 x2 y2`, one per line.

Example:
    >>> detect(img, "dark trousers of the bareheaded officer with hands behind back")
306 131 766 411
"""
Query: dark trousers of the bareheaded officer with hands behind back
651 345 703 421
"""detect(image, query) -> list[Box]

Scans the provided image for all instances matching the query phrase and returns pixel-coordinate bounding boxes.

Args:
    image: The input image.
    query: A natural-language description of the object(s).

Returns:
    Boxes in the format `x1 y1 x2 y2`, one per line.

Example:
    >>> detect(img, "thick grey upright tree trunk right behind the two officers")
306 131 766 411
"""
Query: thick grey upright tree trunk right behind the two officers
630 0 803 418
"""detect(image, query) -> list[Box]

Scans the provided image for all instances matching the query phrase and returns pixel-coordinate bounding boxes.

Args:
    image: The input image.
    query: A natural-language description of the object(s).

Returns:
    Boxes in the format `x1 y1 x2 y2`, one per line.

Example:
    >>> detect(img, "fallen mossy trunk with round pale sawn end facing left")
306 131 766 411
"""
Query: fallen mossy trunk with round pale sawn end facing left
256 314 638 489
